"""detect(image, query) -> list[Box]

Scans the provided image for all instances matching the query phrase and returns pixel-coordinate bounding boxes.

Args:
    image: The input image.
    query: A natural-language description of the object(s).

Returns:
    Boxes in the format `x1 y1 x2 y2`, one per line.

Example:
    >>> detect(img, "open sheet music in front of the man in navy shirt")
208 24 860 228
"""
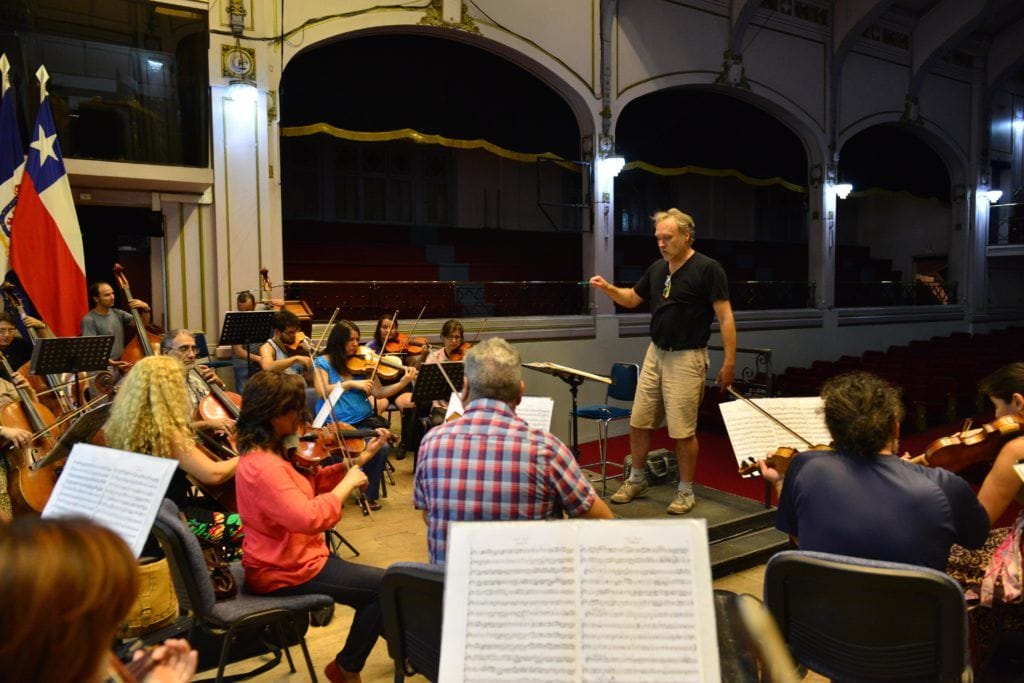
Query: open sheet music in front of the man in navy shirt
719 396 831 467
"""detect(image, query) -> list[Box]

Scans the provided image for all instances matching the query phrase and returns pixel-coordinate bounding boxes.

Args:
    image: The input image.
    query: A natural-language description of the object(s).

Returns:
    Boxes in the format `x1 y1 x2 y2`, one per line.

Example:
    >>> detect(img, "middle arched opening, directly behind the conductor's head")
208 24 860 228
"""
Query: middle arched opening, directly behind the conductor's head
615 88 812 308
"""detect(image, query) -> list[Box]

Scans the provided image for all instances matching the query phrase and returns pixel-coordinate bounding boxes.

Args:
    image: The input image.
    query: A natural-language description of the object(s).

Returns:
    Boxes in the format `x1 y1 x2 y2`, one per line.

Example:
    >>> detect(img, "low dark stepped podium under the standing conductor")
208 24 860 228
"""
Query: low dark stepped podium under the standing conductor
606 481 790 579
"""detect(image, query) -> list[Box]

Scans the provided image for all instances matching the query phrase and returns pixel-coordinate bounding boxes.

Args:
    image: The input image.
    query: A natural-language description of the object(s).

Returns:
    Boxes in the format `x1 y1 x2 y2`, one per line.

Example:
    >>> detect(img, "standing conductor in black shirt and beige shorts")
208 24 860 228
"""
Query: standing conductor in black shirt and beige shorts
590 209 736 515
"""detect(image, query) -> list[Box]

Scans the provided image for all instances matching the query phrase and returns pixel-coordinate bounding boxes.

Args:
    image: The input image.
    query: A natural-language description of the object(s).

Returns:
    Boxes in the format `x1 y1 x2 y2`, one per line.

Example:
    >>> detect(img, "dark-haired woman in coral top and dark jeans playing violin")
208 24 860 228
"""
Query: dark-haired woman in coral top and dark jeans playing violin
238 372 387 683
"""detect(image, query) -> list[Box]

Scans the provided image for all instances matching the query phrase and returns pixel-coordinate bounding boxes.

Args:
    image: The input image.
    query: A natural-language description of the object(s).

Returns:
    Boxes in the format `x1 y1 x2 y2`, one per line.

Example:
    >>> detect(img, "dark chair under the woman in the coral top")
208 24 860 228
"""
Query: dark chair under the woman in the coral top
153 499 334 683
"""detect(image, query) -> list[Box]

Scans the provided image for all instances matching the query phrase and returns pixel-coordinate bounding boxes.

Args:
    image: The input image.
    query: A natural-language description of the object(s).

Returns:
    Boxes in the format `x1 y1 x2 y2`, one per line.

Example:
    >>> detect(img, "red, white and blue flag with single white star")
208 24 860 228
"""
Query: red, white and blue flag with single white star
10 67 89 337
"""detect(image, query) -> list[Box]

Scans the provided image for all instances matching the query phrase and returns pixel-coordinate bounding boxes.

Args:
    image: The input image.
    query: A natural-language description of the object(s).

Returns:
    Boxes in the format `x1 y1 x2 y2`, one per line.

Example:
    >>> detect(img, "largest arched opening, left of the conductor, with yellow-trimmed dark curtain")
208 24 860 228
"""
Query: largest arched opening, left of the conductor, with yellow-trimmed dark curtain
281 34 588 317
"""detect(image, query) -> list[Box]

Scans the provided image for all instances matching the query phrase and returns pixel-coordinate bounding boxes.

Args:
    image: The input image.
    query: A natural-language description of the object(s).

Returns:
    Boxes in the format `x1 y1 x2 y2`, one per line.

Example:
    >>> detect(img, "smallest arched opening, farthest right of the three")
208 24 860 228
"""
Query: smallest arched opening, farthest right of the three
836 124 958 307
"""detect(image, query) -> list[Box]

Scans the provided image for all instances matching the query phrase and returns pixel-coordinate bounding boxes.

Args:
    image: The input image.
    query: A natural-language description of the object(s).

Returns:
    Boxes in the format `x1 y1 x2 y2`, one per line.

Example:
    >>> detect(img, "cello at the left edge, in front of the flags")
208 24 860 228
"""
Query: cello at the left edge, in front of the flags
0 352 57 514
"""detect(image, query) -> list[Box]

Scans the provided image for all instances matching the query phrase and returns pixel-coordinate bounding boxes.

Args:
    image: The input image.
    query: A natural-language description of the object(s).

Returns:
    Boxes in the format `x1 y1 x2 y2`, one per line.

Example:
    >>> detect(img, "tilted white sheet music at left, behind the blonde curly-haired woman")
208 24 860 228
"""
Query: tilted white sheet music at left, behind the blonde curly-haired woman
43 443 178 557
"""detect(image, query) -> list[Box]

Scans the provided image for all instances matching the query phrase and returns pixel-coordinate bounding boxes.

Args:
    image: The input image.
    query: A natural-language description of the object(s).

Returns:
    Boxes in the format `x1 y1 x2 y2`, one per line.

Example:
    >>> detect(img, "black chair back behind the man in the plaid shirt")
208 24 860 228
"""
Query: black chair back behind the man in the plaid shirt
381 562 444 683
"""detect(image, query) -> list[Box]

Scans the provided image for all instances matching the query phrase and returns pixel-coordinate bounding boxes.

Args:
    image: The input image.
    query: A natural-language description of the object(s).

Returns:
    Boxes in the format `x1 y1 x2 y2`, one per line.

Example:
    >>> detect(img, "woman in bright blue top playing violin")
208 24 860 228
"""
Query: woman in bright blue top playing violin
313 321 397 510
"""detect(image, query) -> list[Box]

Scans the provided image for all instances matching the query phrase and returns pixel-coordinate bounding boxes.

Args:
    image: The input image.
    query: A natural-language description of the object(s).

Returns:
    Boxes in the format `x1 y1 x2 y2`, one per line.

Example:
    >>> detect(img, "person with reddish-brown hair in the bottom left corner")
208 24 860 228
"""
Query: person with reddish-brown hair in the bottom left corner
0 516 198 683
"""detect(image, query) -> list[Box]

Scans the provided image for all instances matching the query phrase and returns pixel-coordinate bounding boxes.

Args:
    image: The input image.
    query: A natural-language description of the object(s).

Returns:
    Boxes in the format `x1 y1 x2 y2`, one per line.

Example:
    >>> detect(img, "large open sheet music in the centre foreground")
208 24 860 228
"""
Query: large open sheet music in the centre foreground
439 519 720 683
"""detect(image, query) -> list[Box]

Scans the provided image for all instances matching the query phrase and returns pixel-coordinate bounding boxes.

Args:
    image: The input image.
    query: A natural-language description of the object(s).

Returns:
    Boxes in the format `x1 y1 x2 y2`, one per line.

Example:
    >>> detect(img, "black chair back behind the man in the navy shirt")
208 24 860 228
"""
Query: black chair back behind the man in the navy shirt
764 551 973 683
